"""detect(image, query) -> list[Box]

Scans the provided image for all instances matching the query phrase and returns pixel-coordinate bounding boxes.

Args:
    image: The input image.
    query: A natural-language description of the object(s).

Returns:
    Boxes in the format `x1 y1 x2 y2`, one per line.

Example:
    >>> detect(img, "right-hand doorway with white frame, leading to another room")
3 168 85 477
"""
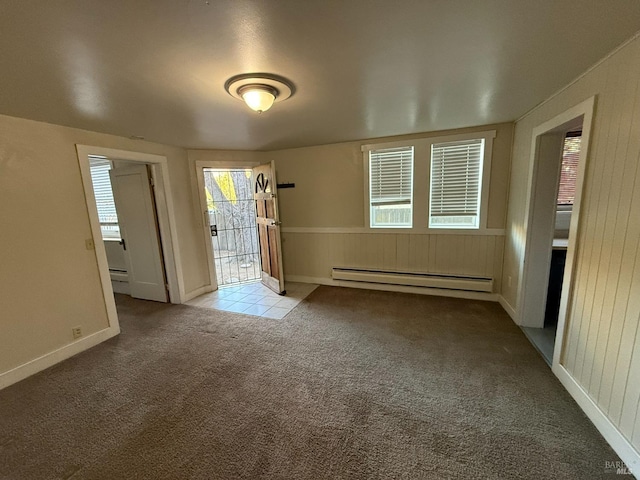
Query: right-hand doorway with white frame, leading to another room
518 98 594 368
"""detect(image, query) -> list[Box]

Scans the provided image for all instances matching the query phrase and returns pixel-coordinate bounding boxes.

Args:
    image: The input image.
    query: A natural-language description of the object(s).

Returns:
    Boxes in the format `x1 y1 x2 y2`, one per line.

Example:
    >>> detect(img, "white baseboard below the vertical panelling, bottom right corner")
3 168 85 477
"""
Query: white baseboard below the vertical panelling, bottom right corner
552 363 640 479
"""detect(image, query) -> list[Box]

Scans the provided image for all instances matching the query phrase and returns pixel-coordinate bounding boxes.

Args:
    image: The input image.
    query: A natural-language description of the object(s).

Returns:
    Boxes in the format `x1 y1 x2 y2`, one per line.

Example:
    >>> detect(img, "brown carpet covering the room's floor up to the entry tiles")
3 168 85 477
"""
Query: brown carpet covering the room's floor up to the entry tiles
0 287 618 480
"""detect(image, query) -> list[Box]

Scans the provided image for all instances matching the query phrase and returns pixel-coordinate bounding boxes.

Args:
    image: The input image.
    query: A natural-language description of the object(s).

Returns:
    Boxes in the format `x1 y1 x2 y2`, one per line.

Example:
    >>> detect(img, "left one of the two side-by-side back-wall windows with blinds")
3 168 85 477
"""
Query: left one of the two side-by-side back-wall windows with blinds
369 146 413 228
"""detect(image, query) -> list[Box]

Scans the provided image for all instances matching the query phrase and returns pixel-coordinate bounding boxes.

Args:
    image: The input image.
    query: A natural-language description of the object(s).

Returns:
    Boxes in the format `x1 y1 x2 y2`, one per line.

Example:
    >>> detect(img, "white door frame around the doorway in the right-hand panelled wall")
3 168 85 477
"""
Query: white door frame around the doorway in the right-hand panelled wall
516 97 595 365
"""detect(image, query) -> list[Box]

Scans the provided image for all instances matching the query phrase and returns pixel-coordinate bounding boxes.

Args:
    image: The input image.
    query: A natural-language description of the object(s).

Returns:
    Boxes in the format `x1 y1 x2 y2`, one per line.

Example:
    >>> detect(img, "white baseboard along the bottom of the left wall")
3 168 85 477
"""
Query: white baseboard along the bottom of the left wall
0 326 120 390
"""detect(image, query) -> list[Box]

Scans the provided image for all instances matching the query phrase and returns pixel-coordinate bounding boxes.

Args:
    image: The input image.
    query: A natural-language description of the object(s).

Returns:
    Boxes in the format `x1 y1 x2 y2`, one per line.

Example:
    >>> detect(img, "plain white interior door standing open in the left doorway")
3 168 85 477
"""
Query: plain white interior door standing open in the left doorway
109 165 167 302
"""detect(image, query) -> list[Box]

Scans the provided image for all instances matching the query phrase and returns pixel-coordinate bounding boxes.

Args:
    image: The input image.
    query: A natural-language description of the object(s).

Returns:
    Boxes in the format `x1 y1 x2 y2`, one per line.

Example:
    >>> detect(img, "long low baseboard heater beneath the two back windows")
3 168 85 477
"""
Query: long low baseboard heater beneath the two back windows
331 267 493 292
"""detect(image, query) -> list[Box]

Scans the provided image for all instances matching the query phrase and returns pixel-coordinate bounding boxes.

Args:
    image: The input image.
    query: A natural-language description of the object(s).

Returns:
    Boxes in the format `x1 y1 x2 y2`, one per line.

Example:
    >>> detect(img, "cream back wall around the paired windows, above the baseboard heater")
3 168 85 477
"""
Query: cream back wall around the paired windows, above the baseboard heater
272 124 513 291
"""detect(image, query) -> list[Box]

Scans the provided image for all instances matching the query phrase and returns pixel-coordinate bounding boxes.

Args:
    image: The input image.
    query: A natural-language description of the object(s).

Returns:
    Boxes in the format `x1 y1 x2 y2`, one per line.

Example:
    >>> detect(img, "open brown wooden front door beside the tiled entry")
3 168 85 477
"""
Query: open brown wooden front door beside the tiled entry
253 162 286 295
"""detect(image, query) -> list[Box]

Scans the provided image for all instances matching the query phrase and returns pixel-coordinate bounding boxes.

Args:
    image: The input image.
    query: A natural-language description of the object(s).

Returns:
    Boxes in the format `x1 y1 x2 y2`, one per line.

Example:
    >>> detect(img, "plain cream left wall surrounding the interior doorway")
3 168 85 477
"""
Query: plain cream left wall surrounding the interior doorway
0 115 207 378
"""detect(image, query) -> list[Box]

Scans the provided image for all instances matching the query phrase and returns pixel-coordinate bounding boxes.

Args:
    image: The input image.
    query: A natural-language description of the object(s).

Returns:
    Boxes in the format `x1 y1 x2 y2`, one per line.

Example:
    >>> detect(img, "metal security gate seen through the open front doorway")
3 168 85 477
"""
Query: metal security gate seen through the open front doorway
204 168 261 287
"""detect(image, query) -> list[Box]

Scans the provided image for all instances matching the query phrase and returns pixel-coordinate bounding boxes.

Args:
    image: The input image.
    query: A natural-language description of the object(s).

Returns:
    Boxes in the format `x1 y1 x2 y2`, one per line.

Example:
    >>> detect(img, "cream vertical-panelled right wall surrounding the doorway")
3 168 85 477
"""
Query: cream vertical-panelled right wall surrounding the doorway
502 32 640 450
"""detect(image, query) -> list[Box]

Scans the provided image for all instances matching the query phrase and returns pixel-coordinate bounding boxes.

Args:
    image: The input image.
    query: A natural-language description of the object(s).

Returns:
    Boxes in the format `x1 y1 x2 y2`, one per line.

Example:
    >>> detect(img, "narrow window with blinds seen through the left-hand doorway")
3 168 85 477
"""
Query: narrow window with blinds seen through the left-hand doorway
89 157 120 240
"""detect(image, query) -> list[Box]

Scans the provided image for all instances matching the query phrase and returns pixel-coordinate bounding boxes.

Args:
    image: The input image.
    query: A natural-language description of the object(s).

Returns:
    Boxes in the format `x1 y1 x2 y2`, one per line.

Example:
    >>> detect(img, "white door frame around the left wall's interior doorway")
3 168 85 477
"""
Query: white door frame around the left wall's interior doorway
76 145 184 325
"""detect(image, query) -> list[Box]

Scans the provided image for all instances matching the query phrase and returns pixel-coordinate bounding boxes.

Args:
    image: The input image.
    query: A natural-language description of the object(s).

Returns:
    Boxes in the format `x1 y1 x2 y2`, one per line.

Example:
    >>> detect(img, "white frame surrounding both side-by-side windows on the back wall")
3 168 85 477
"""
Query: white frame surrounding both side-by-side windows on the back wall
361 130 496 235
